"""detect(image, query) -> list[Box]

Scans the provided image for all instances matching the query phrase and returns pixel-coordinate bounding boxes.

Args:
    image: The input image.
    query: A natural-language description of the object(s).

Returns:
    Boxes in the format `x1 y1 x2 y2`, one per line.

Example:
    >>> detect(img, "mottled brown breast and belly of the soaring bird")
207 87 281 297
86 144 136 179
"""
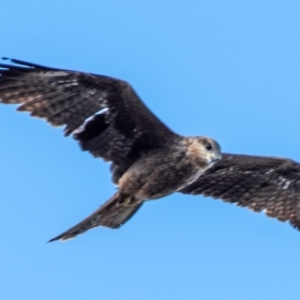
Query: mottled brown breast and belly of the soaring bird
119 149 203 200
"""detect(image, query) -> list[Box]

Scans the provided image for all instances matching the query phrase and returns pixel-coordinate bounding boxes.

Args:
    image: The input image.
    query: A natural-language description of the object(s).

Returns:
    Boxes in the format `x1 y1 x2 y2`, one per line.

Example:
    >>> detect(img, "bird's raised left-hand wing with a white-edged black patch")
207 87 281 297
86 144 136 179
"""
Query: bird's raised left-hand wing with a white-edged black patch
0 59 176 182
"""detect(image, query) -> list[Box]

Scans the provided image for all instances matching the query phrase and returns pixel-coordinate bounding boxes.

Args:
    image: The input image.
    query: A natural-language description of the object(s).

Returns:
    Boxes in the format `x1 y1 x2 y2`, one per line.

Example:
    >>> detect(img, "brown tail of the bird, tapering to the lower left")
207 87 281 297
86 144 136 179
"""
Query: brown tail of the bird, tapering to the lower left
49 192 142 242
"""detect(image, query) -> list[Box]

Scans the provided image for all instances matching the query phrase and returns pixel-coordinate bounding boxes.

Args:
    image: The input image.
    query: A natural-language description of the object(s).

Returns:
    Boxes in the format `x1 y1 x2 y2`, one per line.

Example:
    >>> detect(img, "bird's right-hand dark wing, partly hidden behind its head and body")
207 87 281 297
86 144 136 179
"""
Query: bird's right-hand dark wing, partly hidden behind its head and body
180 154 300 230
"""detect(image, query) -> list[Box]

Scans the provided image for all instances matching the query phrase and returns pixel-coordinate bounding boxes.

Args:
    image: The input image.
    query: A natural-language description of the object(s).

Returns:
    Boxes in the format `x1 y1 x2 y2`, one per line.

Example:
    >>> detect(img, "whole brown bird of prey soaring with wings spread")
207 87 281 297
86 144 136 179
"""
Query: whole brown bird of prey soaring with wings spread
0 59 300 241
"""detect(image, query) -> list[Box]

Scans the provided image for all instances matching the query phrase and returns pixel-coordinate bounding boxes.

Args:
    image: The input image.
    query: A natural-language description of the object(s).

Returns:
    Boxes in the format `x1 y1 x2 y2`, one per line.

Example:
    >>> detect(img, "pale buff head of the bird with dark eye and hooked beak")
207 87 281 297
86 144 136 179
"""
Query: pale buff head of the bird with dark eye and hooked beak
188 136 222 169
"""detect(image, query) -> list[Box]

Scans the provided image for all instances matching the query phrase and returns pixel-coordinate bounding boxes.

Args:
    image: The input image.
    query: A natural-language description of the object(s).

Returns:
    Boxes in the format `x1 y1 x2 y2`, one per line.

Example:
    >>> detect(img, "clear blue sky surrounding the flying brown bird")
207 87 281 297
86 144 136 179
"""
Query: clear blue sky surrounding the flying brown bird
0 0 300 300
